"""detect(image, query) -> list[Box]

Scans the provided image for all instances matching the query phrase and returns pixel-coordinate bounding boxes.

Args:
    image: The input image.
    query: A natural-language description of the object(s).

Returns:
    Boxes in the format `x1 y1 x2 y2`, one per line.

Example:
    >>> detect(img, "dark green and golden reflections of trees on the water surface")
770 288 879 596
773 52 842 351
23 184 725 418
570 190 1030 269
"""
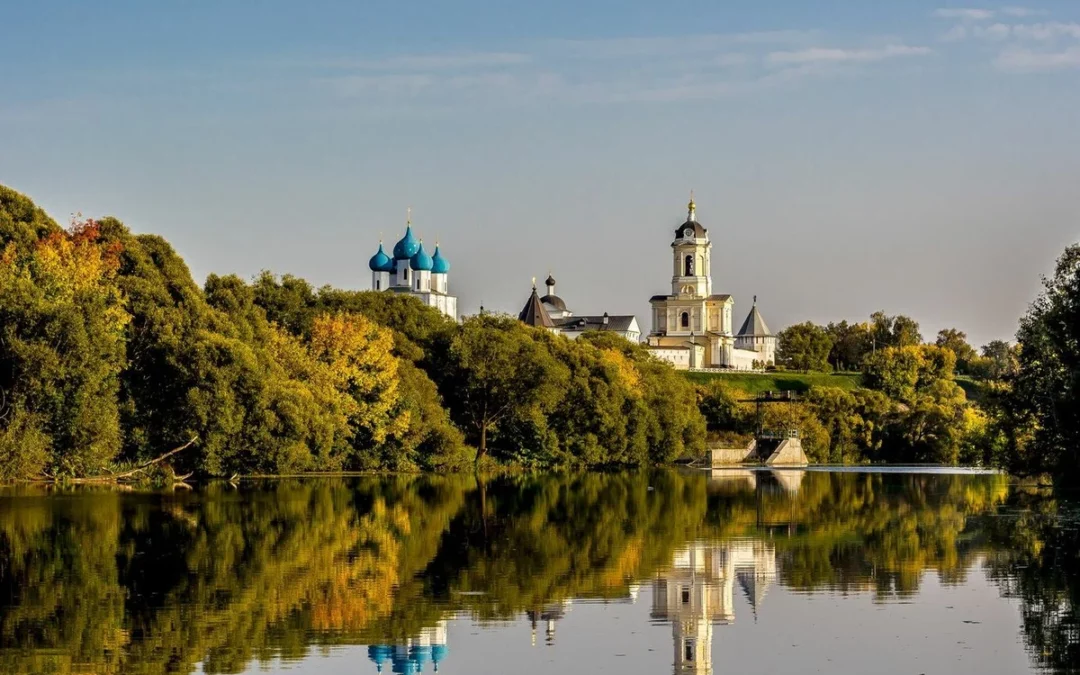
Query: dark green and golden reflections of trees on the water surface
0 471 1078 673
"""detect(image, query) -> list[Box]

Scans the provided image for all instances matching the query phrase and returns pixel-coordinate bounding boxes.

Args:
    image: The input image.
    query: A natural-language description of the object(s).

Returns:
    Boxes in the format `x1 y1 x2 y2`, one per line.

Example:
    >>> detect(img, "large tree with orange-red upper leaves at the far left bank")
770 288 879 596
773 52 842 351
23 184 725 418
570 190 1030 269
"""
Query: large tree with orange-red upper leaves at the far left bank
0 220 131 477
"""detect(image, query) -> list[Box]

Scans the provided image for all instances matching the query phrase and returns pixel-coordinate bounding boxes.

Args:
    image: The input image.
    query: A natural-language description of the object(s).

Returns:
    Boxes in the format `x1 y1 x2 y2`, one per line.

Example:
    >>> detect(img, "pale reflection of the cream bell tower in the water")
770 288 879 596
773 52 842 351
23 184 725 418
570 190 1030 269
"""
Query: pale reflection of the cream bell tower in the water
650 539 777 675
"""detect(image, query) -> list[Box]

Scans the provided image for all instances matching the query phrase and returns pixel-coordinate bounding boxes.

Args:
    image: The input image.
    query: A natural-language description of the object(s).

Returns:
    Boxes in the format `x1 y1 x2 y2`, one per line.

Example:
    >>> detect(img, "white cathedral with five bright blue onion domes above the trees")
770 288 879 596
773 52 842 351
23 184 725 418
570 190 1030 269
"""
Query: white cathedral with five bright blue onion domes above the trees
367 212 458 321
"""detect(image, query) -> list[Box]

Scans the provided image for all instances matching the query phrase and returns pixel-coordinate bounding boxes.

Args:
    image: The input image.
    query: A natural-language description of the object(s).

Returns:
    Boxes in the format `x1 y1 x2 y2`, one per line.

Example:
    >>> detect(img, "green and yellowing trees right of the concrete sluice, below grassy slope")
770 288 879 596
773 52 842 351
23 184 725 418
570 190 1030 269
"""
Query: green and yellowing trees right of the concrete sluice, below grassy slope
751 244 1080 483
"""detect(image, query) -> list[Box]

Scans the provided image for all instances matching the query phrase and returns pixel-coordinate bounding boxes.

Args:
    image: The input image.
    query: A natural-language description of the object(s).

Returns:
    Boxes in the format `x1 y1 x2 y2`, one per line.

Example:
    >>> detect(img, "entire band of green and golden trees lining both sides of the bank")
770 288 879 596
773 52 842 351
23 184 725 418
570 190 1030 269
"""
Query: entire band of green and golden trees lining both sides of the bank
0 186 1080 480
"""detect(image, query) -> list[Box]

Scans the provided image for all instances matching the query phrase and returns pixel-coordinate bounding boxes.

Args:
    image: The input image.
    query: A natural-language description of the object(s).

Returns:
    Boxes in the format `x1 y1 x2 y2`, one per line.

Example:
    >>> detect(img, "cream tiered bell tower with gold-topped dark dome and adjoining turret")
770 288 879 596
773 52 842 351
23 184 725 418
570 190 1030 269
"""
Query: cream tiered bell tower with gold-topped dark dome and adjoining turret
646 194 777 370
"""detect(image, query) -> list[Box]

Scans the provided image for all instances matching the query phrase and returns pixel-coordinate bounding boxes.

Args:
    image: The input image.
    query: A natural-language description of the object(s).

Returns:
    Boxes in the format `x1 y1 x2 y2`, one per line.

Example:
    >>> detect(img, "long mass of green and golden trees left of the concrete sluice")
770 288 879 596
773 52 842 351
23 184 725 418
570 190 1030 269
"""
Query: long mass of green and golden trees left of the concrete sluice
0 187 704 480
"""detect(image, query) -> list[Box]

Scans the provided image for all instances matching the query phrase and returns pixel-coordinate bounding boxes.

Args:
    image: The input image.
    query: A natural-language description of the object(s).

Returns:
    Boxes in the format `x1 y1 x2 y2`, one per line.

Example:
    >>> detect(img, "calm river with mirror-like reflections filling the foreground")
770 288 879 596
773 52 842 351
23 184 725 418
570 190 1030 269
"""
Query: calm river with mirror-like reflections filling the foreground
0 470 1080 675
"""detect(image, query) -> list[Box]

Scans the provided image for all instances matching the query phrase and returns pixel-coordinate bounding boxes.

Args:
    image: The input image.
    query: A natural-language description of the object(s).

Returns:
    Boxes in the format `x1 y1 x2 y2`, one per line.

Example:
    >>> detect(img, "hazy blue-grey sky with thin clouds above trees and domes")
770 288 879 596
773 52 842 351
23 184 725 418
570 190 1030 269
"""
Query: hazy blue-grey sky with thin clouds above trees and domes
0 0 1080 342
